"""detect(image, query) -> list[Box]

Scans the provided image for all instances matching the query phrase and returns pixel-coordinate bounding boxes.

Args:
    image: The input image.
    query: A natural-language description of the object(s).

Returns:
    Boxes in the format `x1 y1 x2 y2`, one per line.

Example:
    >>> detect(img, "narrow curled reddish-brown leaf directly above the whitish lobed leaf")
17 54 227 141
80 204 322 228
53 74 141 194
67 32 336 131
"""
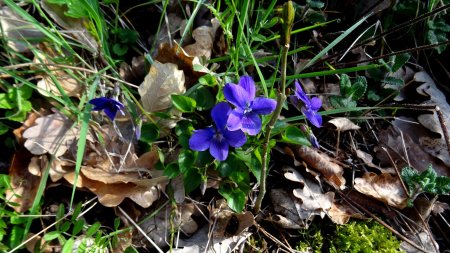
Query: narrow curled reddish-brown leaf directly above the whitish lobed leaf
295 146 345 190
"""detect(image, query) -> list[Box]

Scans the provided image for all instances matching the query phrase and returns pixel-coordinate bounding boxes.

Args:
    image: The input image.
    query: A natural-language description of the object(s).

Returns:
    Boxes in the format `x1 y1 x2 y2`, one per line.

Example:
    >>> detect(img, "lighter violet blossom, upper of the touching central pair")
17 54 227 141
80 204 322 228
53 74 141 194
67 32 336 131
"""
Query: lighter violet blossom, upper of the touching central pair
223 76 277 135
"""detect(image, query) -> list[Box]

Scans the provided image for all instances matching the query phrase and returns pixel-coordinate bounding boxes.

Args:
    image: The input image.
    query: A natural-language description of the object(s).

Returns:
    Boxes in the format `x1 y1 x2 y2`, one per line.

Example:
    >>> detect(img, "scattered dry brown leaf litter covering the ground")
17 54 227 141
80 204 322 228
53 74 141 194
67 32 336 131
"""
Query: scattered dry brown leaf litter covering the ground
0 1 450 252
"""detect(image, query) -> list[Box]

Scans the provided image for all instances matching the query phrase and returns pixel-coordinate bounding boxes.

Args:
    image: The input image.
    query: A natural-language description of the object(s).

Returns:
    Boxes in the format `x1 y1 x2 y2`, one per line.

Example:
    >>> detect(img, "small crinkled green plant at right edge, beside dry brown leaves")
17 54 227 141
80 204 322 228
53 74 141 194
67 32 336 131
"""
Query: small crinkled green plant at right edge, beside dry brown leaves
401 164 450 206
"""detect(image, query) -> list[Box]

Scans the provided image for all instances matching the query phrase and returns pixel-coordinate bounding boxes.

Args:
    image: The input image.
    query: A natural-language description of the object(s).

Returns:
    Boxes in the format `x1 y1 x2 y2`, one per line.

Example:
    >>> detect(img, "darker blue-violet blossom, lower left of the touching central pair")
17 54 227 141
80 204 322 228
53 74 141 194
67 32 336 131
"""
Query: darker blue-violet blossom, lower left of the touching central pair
189 102 247 161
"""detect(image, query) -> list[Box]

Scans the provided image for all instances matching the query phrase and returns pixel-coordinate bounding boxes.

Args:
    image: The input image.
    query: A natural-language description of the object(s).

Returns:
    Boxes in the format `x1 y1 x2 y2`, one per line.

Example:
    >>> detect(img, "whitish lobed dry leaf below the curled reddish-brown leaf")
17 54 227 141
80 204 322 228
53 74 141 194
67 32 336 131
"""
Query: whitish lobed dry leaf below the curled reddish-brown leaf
284 168 334 220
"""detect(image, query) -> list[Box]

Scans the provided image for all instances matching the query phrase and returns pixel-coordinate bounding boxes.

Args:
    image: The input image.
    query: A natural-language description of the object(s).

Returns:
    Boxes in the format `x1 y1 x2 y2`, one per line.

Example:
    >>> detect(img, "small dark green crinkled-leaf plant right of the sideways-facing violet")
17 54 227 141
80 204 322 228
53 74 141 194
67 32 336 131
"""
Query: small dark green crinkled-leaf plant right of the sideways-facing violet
330 74 367 108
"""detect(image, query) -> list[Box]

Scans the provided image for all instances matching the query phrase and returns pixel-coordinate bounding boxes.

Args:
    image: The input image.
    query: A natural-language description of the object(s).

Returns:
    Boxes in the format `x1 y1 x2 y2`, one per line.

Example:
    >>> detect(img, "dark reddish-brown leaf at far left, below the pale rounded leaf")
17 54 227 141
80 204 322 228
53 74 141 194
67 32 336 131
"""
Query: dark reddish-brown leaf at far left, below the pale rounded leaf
5 148 41 213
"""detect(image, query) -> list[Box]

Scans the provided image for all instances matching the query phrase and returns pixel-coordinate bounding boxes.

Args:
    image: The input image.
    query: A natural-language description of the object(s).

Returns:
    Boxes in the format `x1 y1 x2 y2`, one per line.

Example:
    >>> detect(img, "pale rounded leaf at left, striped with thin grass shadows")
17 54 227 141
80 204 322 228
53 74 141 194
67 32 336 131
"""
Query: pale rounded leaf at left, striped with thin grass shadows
23 113 79 157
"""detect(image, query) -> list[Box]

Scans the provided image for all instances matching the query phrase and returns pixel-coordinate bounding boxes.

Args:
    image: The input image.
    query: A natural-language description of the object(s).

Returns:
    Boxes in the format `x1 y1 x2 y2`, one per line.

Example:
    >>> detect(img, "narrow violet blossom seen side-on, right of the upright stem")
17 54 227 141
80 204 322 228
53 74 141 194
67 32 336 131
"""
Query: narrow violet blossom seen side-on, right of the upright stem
291 81 322 127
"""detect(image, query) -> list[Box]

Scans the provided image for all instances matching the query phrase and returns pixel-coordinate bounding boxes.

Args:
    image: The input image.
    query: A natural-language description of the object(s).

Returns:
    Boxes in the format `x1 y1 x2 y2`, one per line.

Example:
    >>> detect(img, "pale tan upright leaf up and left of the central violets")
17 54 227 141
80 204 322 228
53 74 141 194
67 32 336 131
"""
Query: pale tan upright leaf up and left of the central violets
138 61 186 112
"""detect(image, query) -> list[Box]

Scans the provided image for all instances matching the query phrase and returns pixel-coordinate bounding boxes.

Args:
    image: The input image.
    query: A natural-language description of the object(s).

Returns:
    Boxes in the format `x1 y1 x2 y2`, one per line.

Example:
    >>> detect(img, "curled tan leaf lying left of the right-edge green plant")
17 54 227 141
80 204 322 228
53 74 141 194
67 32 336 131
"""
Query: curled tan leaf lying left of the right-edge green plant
354 172 408 209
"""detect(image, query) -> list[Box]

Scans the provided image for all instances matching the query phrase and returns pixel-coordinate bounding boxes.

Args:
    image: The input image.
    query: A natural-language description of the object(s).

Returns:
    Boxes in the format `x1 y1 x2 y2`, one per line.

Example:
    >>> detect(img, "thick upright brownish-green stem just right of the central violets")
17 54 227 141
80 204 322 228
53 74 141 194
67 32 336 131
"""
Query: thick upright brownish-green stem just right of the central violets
253 44 289 213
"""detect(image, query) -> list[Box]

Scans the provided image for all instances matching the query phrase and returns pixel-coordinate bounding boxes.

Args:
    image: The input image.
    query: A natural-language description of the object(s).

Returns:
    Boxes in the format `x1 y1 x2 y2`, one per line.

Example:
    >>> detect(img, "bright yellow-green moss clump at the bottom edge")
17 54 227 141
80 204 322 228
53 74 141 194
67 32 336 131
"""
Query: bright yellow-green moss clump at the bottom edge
330 221 402 253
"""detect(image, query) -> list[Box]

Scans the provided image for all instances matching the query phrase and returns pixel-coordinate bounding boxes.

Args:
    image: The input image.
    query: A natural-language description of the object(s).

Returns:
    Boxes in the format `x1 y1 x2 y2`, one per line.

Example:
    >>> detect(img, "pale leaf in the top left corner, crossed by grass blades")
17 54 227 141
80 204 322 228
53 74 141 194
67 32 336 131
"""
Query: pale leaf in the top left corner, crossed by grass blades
0 6 45 53
